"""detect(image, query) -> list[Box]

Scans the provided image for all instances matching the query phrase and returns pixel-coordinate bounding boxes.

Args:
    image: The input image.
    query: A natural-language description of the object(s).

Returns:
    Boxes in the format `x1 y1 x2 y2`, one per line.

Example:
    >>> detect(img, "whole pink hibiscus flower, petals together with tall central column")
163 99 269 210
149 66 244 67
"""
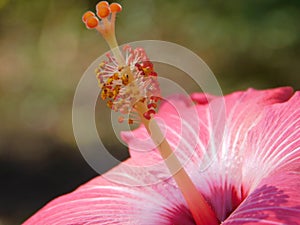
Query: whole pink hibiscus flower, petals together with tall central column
24 1 300 225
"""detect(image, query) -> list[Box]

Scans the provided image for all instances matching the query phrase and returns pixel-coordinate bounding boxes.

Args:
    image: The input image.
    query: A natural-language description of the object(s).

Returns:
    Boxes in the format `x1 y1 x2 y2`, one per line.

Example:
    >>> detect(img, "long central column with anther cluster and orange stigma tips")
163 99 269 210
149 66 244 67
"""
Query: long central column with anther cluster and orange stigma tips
82 1 219 225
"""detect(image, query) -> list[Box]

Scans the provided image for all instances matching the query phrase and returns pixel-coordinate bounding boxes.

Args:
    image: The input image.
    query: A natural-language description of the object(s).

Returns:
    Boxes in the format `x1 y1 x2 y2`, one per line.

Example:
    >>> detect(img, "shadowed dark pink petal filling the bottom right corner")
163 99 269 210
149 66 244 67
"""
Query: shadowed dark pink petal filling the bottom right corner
222 170 300 225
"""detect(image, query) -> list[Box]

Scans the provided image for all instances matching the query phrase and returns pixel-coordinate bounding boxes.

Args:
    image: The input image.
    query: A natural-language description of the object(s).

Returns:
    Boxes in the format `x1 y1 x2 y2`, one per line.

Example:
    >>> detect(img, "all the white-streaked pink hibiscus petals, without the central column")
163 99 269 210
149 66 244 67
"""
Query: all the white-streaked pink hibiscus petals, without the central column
24 88 300 225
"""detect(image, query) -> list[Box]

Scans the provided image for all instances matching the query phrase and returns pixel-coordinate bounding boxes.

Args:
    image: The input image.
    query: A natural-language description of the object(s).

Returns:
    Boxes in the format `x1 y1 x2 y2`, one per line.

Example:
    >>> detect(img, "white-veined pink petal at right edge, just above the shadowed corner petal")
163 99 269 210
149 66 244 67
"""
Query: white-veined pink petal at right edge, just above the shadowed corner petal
237 89 300 191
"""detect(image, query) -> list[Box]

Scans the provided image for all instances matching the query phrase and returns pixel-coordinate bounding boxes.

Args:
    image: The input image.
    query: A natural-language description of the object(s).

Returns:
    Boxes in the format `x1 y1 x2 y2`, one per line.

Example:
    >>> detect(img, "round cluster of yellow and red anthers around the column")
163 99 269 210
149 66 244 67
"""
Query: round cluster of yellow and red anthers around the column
96 46 160 121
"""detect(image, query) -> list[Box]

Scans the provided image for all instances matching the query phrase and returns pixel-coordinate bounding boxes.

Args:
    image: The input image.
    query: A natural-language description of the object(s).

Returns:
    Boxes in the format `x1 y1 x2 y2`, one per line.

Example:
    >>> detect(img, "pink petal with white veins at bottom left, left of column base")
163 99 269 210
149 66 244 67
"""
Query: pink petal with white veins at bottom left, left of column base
24 159 194 225
